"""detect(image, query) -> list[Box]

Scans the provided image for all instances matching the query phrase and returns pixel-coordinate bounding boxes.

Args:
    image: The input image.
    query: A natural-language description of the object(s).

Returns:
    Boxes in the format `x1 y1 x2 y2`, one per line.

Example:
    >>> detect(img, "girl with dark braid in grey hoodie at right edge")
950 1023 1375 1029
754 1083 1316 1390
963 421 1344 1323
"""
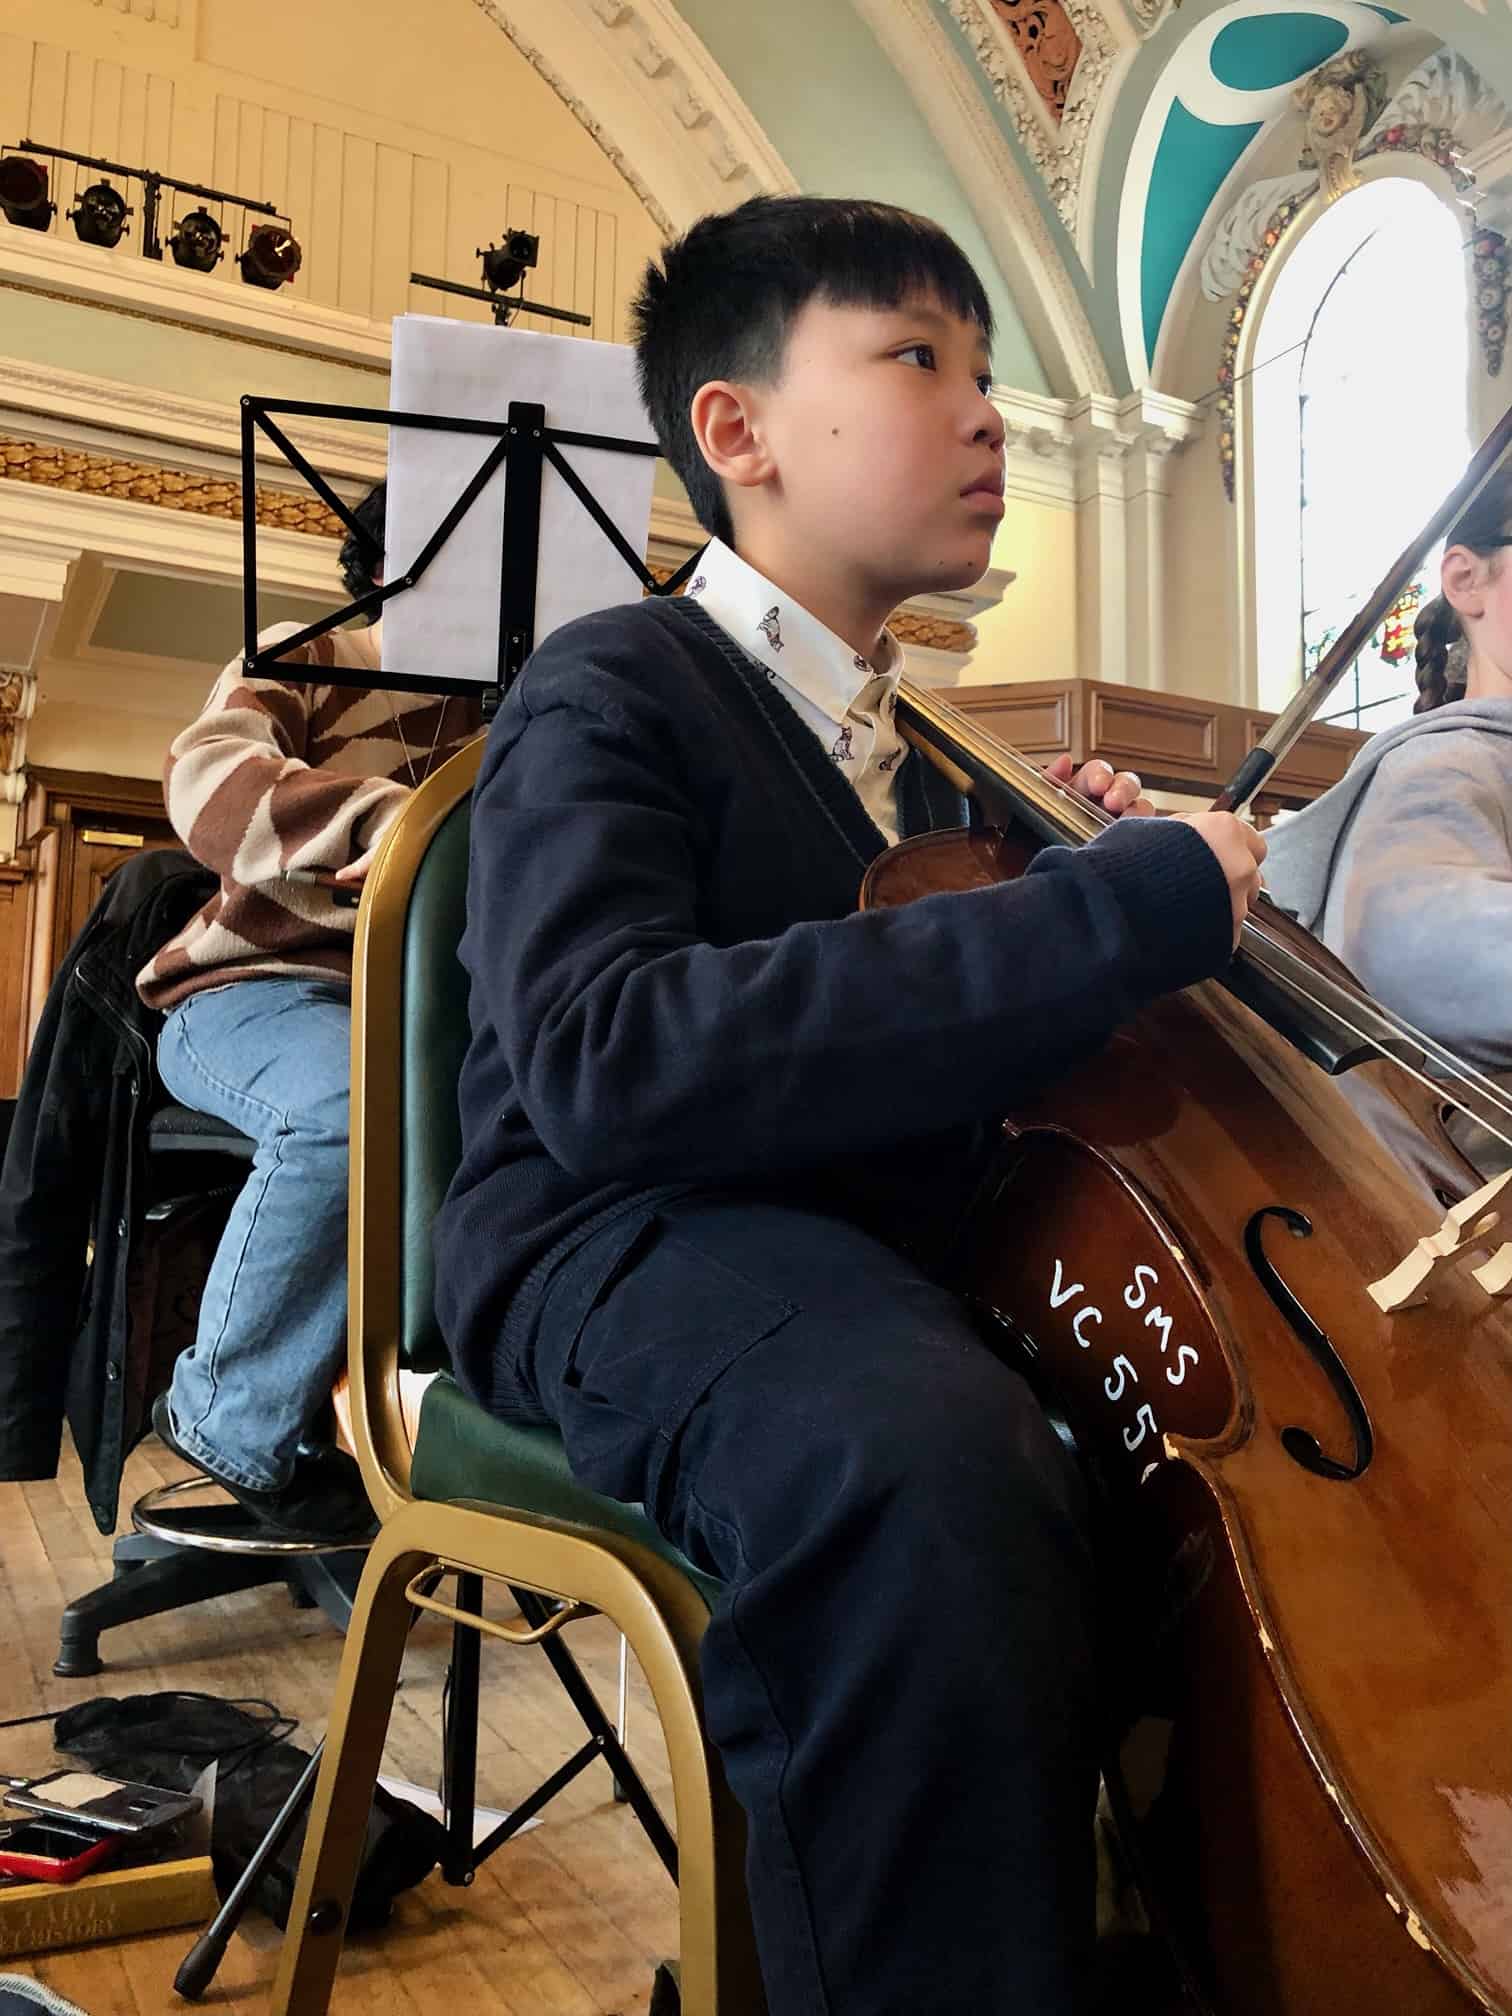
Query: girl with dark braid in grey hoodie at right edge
1266 468 1512 1175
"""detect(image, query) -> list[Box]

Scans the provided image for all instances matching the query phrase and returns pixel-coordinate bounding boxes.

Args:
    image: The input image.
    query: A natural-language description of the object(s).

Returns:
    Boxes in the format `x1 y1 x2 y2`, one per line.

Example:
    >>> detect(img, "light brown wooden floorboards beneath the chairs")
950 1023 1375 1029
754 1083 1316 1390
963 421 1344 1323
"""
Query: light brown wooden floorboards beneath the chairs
0 1441 677 2016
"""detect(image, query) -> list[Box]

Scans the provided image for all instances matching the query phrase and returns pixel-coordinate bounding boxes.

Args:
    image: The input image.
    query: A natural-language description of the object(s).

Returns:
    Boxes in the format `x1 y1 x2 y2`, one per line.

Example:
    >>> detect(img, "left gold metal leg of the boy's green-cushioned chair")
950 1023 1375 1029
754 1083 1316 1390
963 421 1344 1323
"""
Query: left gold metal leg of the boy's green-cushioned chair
268 1514 433 2016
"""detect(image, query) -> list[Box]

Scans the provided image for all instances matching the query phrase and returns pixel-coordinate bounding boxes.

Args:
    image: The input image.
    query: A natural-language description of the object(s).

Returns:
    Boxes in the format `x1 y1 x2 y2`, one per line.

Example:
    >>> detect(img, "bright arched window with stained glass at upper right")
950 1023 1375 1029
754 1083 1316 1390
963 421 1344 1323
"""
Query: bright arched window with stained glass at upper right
1250 175 1472 730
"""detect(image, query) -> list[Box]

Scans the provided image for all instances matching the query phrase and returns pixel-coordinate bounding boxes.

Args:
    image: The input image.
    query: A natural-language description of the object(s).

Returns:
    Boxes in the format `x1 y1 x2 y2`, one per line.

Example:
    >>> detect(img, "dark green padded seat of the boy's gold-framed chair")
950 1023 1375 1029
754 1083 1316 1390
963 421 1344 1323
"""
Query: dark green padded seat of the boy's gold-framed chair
409 1373 724 1609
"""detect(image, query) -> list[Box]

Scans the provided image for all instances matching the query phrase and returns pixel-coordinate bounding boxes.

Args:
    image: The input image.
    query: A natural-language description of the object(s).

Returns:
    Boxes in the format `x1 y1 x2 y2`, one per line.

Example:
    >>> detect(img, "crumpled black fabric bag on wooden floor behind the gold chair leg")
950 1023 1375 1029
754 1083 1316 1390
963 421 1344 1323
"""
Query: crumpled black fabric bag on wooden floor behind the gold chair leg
52 1693 444 1931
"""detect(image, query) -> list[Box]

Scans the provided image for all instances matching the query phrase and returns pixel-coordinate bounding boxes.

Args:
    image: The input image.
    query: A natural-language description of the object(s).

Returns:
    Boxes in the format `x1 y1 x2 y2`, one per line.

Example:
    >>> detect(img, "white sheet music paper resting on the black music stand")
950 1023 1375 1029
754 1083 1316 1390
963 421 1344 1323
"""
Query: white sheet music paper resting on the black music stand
383 314 655 685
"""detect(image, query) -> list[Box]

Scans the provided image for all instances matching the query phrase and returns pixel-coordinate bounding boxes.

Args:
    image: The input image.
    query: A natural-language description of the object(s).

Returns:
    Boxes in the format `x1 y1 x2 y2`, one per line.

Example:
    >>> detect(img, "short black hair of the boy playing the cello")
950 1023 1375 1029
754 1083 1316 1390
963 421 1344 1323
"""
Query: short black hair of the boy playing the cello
631 196 992 544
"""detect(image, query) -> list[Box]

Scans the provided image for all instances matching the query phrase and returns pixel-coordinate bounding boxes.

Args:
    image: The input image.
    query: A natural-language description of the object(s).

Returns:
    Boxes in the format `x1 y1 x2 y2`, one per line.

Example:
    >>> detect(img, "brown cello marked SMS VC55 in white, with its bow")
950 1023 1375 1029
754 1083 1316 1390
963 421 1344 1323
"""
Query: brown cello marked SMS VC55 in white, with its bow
863 413 1512 2016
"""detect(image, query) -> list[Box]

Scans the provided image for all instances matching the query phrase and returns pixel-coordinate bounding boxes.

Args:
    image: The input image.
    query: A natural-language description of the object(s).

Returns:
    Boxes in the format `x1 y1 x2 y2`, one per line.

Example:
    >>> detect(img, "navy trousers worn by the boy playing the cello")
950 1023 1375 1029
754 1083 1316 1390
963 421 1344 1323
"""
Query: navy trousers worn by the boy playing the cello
498 1198 1097 2016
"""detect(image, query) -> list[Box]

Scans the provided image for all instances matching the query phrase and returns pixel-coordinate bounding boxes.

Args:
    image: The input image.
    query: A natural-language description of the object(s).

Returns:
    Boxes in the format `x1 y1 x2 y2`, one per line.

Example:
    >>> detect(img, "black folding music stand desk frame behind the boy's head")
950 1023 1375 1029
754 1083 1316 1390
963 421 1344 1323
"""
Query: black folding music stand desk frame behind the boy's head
242 395 700 720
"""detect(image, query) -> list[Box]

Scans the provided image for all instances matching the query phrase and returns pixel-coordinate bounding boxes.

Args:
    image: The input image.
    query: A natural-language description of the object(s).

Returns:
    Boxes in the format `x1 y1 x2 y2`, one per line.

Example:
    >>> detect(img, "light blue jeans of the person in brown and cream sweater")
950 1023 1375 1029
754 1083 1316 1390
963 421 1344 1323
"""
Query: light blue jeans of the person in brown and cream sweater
157 980 351 1490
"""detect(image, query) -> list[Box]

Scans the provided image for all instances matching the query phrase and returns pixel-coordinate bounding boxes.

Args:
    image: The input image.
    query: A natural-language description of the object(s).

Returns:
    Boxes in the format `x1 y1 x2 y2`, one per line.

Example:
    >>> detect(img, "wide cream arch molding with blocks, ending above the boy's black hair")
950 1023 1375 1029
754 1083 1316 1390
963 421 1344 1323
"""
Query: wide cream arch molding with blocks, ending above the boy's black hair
474 0 798 238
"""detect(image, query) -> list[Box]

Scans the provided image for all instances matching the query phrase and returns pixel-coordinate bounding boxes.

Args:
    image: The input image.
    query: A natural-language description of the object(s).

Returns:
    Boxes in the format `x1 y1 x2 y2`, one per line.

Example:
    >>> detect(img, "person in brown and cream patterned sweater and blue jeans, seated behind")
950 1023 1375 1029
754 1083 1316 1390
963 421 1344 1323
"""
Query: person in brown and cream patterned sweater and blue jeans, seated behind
137 484 482 1538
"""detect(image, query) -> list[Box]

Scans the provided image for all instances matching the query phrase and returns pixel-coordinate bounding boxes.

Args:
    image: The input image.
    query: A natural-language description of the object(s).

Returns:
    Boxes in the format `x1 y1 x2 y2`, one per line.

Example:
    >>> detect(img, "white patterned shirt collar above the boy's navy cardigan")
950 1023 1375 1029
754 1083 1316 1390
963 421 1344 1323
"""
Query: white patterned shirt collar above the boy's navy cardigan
687 538 905 728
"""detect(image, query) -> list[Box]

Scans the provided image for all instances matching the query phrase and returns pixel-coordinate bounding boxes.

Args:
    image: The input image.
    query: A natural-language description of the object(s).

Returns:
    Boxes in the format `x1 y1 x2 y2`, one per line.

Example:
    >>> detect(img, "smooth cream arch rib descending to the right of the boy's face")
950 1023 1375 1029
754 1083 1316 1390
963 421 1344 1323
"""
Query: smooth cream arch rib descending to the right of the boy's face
851 0 1113 397
